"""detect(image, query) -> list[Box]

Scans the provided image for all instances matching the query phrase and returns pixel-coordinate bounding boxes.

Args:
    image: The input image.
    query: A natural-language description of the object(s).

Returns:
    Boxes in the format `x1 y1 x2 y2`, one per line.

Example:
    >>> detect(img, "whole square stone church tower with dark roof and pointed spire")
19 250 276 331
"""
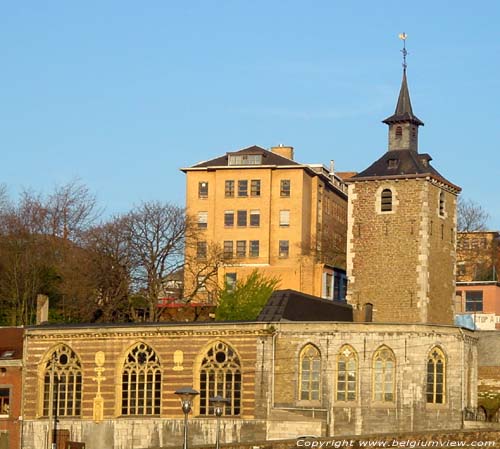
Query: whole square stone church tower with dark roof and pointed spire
347 66 460 324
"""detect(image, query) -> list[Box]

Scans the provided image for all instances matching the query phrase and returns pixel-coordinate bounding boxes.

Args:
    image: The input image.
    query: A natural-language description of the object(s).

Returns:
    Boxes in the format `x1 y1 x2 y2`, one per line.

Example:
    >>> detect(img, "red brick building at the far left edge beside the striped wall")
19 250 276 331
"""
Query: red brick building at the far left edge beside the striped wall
0 327 23 449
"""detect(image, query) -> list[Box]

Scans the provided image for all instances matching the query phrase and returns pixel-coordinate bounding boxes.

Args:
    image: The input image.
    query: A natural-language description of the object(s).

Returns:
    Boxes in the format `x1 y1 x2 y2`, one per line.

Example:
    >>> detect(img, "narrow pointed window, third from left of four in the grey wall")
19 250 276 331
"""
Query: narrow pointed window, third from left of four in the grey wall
373 346 396 402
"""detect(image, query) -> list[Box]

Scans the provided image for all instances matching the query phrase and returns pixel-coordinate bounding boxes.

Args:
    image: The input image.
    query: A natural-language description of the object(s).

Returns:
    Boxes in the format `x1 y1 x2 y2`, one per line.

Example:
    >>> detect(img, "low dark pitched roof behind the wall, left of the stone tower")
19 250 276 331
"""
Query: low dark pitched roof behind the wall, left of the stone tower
257 289 353 322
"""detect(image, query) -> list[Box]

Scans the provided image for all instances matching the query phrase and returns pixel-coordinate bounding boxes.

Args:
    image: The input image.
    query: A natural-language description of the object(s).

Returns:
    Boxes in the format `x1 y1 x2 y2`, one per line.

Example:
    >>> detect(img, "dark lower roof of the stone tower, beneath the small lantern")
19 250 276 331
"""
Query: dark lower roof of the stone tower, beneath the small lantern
346 150 461 191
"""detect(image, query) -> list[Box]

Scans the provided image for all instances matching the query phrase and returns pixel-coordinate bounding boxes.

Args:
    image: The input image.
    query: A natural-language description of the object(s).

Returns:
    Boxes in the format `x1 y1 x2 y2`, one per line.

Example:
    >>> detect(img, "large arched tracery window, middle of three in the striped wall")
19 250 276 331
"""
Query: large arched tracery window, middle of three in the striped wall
122 343 162 415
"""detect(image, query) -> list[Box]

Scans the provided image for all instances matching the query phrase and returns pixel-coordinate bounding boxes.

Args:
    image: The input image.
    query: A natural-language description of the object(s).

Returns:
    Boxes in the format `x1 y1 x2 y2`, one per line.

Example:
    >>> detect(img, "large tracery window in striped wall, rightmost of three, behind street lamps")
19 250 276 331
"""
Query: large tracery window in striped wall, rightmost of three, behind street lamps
200 341 242 416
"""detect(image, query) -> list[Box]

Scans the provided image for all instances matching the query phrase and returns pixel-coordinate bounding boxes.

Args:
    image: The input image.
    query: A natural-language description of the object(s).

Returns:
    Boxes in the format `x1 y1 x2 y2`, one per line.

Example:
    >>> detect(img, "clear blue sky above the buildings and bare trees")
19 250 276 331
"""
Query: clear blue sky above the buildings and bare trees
0 0 500 229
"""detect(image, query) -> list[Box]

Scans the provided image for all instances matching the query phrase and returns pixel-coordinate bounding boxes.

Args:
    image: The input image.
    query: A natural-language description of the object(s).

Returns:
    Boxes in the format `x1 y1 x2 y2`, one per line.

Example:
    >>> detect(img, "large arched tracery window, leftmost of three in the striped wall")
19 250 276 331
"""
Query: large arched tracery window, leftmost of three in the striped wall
43 345 82 417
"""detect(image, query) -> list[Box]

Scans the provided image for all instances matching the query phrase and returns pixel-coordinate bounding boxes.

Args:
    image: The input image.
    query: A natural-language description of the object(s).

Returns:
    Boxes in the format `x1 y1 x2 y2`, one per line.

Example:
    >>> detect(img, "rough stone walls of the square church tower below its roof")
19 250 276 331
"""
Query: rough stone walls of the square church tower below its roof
348 179 455 324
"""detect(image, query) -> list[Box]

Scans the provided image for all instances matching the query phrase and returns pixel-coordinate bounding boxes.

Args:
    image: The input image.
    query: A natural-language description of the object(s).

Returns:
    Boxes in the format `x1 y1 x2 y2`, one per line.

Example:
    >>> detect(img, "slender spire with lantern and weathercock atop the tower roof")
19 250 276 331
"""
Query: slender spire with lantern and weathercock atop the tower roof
383 33 424 152
